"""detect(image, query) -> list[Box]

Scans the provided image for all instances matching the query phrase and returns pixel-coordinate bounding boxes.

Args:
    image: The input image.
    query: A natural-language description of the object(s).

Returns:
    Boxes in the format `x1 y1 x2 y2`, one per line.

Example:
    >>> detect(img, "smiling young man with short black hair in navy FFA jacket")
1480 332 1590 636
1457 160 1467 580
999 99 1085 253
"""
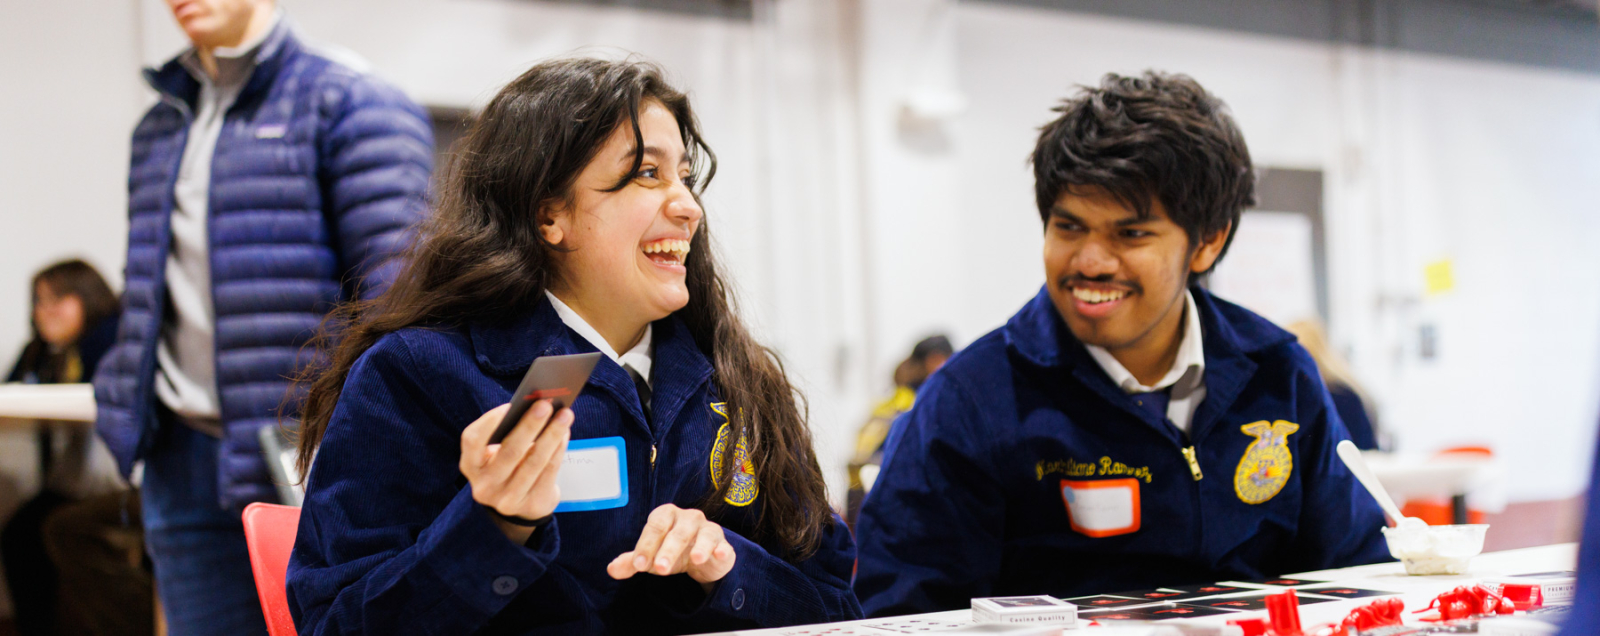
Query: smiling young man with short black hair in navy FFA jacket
856 72 1389 615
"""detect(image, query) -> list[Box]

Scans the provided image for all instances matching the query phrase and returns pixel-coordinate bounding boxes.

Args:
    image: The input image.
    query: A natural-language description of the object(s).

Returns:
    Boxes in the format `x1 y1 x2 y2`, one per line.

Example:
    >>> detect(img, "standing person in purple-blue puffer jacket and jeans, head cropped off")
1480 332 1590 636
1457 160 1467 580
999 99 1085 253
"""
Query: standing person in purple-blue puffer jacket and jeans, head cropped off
94 0 434 636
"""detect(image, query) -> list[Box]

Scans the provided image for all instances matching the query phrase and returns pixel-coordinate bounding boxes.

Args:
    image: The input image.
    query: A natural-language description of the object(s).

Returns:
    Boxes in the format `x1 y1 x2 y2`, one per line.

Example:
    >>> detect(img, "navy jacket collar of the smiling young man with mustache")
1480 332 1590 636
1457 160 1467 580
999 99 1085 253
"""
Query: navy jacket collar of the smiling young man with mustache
1003 286 1294 439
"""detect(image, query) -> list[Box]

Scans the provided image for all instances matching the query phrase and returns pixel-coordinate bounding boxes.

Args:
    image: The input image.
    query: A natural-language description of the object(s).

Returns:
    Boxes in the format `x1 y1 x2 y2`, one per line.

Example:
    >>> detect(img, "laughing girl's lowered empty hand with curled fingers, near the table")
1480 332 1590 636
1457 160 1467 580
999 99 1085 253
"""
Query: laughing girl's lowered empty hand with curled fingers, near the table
606 503 734 593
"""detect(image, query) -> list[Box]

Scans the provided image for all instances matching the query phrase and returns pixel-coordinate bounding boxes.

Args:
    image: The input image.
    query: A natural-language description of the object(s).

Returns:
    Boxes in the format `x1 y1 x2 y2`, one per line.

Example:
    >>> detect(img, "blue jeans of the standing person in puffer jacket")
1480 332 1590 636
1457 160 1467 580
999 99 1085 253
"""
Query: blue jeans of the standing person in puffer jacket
144 418 267 636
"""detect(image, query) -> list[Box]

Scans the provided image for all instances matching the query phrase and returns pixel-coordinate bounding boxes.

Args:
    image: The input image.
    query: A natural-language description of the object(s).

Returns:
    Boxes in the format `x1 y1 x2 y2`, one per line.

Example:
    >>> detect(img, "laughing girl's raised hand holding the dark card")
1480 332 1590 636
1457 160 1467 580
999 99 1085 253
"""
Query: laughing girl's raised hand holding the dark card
461 399 573 543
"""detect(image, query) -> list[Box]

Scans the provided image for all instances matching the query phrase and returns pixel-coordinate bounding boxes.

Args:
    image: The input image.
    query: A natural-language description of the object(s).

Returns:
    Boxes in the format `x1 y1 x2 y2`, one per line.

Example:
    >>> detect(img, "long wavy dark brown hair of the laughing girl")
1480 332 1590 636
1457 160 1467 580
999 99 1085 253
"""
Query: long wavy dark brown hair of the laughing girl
298 59 832 561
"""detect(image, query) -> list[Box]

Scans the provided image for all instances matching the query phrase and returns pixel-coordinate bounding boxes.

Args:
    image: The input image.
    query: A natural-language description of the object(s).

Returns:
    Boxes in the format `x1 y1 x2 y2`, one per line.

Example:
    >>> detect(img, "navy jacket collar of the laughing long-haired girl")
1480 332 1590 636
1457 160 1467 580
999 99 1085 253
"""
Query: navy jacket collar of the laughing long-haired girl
466 296 712 436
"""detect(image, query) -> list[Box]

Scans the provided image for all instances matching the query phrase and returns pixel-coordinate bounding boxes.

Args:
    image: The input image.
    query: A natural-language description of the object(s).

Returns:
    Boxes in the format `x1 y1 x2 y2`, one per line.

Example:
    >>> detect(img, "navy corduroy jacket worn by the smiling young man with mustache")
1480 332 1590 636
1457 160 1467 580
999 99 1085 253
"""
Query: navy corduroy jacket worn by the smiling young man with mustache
854 288 1389 615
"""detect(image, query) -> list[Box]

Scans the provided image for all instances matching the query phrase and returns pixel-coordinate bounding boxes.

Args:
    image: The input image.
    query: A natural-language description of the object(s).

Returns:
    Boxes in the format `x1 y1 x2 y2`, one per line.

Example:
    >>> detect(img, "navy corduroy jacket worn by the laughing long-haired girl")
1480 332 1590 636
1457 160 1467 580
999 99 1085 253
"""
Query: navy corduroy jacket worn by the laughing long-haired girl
288 299 861 636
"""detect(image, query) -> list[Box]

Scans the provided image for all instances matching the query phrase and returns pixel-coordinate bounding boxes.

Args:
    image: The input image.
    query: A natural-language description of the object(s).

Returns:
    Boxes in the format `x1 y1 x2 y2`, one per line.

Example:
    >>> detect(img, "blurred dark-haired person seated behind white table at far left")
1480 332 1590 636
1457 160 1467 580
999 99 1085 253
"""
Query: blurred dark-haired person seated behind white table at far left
0 259 117 636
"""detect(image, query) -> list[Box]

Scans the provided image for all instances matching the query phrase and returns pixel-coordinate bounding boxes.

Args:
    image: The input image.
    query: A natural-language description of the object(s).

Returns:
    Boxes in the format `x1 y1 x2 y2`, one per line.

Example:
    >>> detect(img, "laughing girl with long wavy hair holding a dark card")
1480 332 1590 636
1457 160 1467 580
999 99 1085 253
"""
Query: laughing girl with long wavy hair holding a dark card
288 59 861 636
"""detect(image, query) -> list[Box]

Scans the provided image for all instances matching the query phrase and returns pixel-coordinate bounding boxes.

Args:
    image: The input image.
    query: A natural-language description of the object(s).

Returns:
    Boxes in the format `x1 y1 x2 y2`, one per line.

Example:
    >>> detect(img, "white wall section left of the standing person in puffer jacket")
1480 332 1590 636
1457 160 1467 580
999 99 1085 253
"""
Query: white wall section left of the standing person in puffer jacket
0 0 142 362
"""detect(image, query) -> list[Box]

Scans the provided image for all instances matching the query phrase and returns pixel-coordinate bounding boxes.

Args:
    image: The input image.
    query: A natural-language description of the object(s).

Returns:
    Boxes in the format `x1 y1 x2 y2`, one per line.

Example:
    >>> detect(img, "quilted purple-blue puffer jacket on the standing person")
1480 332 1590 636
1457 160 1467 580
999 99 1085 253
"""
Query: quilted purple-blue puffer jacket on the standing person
94 22 434 510
